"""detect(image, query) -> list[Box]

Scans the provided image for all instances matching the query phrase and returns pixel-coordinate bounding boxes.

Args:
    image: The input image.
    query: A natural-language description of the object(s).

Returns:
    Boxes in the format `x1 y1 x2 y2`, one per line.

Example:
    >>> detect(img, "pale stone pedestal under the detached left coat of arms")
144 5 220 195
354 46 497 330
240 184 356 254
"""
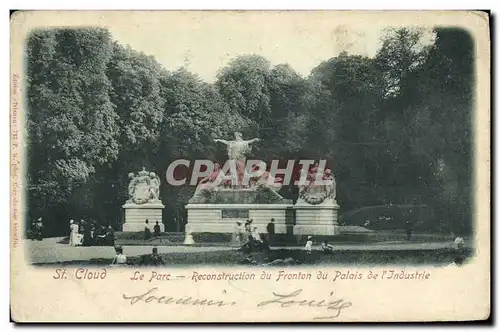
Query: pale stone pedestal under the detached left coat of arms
123 202 165 232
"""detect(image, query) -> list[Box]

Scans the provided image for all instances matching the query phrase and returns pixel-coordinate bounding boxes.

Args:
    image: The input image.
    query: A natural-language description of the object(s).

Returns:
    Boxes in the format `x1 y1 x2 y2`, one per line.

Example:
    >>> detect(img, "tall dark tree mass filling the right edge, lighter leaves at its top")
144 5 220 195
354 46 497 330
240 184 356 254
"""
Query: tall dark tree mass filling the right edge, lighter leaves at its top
377 29 473 232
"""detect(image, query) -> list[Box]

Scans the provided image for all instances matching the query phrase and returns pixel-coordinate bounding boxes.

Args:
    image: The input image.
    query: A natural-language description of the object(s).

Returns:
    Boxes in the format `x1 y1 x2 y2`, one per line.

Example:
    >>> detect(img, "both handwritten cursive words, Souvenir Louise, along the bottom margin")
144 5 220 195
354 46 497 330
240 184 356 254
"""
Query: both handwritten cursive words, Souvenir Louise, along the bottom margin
123 287 352 320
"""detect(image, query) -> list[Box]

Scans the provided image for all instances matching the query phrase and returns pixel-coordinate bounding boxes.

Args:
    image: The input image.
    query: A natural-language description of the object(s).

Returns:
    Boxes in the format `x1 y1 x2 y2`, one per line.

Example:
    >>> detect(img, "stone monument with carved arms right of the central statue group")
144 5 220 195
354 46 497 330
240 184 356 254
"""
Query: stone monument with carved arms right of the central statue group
293 164 340 236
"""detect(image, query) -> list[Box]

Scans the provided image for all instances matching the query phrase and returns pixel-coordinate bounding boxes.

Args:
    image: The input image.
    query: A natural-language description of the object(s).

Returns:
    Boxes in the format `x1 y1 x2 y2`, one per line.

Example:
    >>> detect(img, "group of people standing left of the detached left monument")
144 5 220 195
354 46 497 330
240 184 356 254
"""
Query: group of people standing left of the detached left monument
69 219 115 247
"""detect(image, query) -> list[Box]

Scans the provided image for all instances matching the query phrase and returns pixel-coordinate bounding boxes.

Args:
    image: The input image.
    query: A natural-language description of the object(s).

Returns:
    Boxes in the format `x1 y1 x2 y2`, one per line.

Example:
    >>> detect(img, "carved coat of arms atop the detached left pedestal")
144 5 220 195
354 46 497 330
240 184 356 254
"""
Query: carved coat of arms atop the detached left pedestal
127 168 160 204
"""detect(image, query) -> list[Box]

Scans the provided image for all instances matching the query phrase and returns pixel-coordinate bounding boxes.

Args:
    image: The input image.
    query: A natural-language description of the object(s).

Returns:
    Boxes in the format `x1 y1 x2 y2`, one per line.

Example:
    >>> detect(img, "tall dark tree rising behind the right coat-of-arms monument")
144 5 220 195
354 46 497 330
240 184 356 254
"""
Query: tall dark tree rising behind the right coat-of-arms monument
307 52 381 208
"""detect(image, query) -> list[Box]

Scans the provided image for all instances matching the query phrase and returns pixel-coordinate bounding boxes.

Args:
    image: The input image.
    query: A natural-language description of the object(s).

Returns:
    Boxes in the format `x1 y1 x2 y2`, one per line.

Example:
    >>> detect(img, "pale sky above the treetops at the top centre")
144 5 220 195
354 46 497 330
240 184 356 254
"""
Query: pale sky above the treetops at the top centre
109 12 386 82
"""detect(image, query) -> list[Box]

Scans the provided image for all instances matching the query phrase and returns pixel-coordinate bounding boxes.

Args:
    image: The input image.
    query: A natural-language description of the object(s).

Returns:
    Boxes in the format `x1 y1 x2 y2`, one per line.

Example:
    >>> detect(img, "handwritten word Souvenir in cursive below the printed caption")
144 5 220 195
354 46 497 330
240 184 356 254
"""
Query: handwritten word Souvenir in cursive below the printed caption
123 287 236 307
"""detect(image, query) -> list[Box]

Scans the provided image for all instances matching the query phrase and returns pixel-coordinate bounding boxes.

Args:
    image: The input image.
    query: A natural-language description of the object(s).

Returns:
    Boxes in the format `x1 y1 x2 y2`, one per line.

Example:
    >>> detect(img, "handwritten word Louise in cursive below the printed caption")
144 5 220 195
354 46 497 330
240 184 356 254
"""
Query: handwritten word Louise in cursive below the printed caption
257 289 352 319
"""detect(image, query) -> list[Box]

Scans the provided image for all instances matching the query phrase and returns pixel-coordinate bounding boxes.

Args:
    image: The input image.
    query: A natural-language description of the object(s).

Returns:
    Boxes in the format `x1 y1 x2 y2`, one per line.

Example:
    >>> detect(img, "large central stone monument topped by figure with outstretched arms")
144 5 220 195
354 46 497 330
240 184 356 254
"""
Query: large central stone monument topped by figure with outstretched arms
186 132 293 244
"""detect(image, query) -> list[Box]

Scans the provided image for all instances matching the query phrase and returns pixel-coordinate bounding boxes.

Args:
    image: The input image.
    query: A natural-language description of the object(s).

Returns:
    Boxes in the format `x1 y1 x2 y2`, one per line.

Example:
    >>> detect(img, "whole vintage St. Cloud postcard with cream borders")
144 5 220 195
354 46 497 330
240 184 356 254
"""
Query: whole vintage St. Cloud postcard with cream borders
10 11 491 323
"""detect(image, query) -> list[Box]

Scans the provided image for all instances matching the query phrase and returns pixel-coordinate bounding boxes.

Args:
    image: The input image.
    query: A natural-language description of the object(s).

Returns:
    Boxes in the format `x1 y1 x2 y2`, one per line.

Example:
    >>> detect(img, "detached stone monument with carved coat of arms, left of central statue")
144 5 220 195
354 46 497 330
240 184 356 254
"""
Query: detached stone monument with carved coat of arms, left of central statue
123 167 165 232
